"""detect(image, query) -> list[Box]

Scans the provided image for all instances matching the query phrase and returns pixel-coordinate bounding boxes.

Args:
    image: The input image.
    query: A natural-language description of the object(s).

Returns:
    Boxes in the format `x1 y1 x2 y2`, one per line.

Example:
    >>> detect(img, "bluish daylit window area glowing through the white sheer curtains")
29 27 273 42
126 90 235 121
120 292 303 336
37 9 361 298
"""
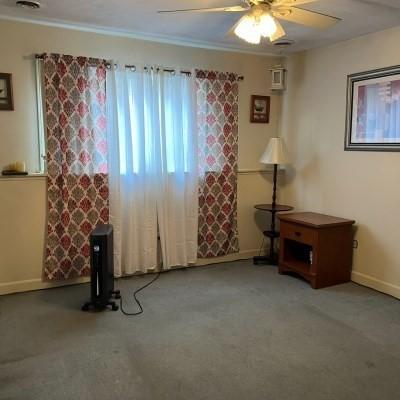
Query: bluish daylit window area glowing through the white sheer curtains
111 71 197 175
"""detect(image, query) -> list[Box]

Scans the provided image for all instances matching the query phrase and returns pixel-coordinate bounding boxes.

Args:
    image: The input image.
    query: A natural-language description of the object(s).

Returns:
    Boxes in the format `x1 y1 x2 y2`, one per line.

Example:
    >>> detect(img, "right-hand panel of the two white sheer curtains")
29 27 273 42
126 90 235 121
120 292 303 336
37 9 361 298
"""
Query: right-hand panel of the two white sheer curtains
157 73 199 268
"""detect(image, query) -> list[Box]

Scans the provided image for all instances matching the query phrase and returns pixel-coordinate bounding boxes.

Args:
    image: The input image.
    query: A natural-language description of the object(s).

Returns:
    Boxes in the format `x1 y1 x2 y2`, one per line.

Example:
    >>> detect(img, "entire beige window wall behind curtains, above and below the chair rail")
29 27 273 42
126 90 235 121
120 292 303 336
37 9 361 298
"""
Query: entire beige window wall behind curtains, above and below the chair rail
0 20 281 293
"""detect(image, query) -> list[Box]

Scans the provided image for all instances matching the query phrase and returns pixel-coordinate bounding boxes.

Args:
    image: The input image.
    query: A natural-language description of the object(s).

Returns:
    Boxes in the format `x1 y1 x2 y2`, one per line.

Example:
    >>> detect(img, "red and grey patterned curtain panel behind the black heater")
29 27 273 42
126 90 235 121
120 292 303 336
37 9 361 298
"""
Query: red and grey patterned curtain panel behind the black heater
43 54 109 280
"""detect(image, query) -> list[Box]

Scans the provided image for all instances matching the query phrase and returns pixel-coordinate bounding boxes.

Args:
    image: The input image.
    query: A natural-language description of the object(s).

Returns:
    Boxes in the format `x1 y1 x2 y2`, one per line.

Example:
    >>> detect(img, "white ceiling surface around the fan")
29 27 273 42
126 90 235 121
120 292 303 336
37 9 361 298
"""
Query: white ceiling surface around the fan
0 0 400 54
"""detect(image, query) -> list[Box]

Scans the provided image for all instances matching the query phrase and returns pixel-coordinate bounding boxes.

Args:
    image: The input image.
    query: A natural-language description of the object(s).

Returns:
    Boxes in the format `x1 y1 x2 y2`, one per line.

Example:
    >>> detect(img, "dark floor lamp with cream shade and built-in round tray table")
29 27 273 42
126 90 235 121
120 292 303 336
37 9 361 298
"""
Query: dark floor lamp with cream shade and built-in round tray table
254 137 293 264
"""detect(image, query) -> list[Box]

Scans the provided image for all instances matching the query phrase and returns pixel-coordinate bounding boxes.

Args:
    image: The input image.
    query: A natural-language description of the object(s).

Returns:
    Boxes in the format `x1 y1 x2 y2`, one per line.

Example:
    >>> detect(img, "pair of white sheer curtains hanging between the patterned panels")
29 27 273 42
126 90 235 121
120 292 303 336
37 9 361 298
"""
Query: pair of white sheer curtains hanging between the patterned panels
107 69 198 276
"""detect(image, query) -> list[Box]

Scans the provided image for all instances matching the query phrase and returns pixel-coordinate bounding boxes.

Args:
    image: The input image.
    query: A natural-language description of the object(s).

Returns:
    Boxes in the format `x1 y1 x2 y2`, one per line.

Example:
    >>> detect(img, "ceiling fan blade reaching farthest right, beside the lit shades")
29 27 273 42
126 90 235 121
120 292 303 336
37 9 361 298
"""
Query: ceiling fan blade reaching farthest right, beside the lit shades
273 7 341 29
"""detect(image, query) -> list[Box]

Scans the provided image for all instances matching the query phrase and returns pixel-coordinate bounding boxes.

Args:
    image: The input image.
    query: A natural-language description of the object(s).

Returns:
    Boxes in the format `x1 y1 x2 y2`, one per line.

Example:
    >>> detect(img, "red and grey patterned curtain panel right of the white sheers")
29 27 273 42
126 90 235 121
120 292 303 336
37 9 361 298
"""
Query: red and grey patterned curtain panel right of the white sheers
196 70 239 258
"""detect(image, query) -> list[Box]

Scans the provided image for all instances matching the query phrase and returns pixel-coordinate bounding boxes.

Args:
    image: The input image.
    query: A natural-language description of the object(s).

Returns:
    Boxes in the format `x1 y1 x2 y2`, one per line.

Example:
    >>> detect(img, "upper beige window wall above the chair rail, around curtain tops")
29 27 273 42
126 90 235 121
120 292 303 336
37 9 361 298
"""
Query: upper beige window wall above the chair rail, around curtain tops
0 20 281 171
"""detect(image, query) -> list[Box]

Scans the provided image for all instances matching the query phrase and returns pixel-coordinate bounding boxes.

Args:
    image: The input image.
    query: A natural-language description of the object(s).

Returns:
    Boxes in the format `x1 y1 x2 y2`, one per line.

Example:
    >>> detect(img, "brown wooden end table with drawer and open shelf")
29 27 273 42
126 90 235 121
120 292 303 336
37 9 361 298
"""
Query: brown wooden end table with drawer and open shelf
279 212 355 289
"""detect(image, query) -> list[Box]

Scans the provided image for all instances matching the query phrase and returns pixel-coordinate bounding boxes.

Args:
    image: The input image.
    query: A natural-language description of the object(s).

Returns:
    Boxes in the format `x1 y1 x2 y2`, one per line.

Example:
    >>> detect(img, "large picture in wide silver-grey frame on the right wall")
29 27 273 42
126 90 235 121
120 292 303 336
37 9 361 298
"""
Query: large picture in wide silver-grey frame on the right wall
344 66 400 151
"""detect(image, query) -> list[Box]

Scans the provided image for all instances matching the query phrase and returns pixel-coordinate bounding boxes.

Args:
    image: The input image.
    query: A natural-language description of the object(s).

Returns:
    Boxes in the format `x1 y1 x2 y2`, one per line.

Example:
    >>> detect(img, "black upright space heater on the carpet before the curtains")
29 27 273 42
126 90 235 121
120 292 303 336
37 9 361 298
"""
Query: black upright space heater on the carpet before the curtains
82 224 121 311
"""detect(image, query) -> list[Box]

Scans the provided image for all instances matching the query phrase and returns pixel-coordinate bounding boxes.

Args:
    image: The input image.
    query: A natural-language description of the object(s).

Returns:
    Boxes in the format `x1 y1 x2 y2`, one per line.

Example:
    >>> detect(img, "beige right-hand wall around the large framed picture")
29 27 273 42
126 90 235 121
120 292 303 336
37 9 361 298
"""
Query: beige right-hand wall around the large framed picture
282 28 400 297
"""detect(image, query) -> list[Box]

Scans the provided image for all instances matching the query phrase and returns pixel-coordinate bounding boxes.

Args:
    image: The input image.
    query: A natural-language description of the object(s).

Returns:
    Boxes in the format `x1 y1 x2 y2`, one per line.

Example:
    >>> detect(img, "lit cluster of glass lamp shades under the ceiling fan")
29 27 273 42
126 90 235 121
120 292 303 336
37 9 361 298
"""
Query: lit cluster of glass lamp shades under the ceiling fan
234 11 277 44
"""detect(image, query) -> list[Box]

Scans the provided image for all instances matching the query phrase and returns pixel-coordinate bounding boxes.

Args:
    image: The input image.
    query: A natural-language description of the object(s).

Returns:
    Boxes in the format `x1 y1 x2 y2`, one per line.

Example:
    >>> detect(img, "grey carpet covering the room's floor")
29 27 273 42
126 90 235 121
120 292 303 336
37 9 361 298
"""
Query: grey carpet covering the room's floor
0 261 400 400
